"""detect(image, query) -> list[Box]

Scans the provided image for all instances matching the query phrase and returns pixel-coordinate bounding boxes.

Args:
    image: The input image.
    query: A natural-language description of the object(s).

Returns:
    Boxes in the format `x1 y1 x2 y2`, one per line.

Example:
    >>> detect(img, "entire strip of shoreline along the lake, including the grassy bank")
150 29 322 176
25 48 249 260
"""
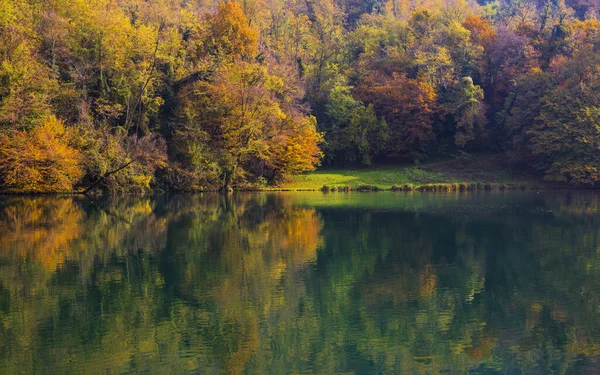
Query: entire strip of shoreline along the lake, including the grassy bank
0 155 572 197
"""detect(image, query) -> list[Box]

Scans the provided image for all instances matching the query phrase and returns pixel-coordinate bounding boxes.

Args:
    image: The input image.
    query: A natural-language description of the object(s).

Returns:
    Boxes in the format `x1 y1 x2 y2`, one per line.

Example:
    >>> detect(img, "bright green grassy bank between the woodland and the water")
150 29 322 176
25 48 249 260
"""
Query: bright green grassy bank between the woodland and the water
281 156 542 191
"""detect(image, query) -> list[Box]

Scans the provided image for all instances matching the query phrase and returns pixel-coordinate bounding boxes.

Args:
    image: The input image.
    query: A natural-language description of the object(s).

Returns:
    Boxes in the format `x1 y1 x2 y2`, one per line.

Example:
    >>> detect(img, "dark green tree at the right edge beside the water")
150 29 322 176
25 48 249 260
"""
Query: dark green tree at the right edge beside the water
527 50 600 185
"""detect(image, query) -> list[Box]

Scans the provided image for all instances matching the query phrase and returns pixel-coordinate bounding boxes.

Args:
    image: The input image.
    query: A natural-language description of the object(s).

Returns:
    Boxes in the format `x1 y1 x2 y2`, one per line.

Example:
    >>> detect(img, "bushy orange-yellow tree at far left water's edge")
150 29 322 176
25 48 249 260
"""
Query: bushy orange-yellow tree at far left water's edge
0 117 83 193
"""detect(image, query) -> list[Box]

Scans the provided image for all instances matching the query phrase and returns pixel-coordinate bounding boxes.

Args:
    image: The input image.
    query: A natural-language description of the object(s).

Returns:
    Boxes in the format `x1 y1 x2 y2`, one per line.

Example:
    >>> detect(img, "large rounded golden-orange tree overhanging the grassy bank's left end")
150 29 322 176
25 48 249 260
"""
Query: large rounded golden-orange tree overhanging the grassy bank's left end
179 62 320 190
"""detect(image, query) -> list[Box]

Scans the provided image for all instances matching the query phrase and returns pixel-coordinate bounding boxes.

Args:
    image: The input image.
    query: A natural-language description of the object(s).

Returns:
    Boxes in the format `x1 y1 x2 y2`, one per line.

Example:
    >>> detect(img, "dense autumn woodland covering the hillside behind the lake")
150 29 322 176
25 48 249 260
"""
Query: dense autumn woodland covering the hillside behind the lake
0 0 600 192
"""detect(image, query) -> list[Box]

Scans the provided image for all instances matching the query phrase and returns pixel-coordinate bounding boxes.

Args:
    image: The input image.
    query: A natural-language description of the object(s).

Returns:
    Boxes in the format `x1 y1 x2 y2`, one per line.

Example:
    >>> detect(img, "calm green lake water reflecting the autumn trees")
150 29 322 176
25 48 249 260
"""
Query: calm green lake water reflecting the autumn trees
0 192 600 374
